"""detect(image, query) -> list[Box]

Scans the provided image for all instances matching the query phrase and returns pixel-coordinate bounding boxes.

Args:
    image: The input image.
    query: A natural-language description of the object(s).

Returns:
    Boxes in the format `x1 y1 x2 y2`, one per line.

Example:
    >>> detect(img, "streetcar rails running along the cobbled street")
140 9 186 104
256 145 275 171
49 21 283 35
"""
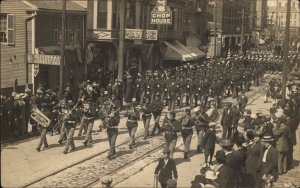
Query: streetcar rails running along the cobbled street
21 74 271 187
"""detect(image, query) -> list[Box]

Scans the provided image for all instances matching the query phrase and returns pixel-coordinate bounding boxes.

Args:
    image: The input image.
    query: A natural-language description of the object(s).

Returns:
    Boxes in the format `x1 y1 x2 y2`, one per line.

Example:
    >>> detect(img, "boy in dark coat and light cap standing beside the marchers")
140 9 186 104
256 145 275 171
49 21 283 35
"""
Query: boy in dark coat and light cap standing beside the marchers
201 122 217 166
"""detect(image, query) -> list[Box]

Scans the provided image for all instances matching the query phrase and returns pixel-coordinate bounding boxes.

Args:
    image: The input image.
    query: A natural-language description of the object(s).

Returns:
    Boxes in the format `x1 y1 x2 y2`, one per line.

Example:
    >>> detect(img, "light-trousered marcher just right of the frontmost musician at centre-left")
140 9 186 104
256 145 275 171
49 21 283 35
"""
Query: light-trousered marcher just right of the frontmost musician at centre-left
126 104 140 149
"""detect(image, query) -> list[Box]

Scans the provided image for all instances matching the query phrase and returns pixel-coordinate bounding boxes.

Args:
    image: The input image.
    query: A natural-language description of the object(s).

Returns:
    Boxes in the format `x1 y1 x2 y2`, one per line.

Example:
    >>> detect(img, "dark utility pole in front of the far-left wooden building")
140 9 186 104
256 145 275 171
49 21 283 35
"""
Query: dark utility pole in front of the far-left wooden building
59 0 67 98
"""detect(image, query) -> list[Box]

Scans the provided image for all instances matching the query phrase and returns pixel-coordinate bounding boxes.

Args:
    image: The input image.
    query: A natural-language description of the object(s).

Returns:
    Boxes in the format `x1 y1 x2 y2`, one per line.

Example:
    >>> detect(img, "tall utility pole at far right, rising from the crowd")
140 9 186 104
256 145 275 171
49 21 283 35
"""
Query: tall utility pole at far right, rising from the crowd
281 0 291 98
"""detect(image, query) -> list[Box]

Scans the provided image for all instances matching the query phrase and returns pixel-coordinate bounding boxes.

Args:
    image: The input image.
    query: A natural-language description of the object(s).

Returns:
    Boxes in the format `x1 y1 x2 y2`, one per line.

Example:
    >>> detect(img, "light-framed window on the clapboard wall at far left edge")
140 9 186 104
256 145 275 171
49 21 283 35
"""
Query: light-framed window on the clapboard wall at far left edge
0 14 15 45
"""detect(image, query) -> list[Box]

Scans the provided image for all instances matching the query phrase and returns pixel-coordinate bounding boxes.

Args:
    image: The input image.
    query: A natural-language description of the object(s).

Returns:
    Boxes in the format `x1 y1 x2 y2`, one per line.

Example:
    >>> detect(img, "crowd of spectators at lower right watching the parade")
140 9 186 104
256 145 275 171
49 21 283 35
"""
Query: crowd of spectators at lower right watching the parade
155 80 300 188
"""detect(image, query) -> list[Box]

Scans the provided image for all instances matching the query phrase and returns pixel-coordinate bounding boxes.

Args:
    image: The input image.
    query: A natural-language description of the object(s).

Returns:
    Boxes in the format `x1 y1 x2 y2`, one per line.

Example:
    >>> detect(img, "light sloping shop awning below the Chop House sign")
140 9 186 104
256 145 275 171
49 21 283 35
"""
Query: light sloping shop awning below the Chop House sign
163 41 197 61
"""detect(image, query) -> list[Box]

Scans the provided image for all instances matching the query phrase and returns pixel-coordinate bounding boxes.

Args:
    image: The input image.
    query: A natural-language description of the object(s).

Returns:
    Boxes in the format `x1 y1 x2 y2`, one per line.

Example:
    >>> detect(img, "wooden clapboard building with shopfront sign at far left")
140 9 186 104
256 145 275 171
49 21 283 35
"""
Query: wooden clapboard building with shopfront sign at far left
0 0 86 93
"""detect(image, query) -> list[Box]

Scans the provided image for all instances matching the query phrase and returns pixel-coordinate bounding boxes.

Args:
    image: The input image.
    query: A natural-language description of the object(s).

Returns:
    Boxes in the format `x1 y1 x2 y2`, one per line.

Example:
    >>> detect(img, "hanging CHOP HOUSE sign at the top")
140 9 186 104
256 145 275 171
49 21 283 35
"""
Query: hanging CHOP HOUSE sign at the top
151 0 172 25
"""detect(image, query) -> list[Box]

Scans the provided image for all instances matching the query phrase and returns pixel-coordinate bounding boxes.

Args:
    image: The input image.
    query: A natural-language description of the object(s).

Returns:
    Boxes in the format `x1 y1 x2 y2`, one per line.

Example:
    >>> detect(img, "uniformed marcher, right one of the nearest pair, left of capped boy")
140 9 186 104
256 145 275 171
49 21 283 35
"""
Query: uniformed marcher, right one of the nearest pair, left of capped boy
180 108 195 159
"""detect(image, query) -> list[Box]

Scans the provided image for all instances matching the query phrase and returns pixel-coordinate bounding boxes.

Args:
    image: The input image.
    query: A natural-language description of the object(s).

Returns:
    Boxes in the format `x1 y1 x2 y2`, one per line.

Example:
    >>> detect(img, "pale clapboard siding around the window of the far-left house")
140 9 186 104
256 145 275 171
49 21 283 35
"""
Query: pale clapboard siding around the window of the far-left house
0 1 32 89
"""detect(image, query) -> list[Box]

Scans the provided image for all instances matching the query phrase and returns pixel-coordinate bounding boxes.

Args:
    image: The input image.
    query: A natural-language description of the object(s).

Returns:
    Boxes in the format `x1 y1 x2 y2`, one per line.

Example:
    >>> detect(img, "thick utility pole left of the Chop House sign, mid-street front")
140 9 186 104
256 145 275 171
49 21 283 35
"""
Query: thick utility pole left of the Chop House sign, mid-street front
118 0 126 80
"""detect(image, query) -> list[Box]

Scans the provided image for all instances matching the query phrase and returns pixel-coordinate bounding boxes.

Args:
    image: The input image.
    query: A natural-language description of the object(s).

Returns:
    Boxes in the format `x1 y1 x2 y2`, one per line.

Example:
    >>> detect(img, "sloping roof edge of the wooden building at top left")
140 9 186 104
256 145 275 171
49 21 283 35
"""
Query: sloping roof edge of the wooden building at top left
24 0 87 12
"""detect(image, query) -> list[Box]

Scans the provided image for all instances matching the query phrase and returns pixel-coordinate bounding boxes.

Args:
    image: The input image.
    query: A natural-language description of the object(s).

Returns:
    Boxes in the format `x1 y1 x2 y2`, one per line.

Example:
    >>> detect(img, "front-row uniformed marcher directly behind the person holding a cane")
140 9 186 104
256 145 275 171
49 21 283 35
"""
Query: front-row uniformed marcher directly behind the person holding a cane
162 112 181 159
